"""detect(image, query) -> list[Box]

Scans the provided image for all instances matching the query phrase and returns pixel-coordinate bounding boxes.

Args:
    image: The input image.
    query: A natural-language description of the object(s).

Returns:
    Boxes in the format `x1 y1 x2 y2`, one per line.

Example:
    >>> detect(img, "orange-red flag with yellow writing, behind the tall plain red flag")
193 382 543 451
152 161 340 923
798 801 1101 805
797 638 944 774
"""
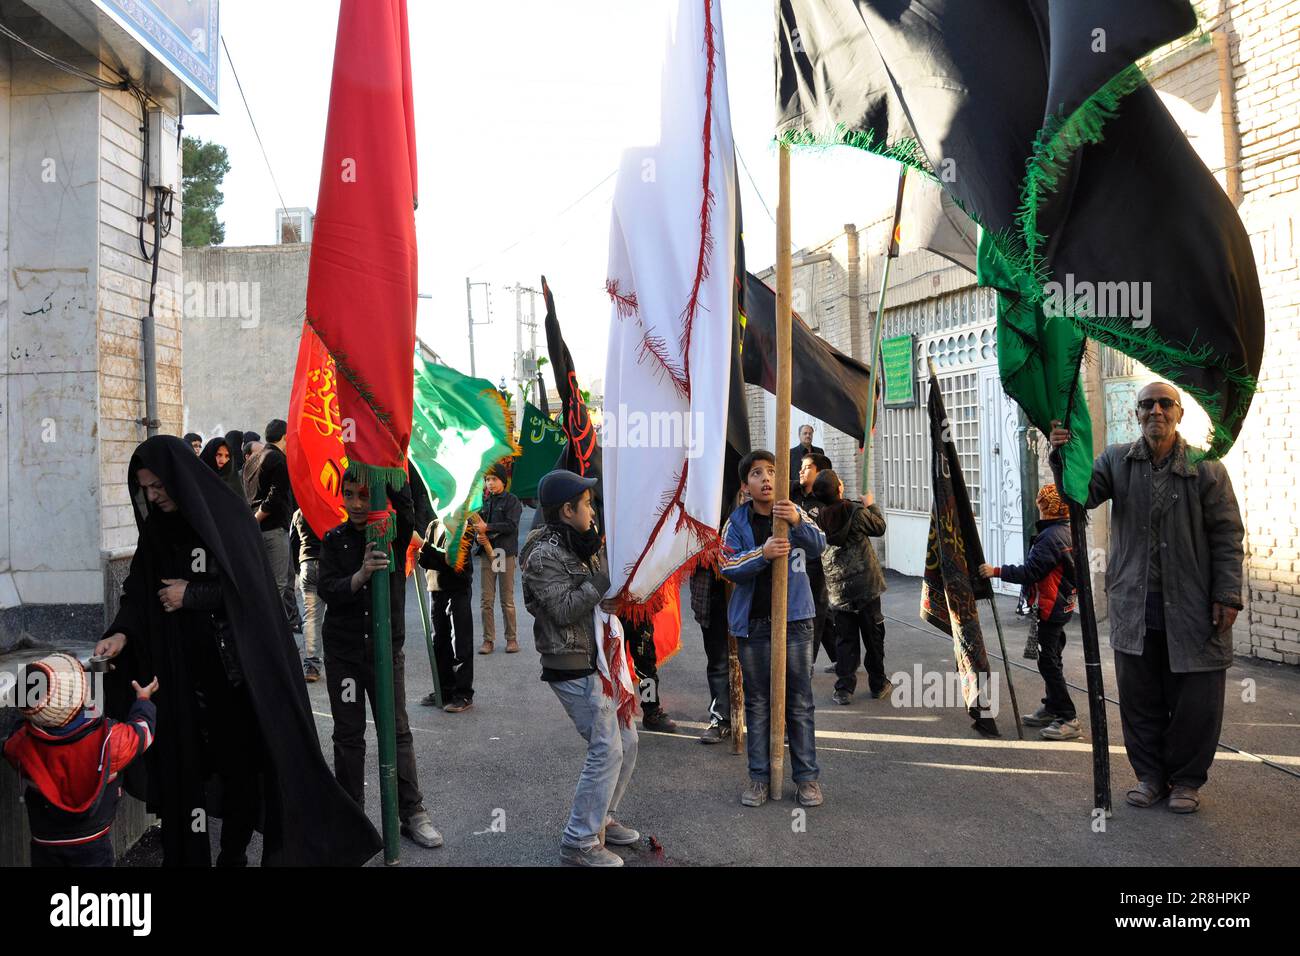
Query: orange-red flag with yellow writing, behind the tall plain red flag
286 323 347 537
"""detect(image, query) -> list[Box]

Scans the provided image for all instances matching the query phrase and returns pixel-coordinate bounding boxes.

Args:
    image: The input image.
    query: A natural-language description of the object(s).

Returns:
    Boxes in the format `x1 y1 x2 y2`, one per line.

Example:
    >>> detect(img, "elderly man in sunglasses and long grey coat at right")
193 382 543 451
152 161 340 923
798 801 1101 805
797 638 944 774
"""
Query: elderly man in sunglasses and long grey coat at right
1050 382 1244 813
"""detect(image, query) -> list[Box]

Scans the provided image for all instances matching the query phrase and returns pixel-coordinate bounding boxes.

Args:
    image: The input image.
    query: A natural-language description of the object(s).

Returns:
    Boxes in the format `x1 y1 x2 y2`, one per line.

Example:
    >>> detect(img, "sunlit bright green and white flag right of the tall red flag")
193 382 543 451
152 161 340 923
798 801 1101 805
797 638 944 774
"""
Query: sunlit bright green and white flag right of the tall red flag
410 355 519 568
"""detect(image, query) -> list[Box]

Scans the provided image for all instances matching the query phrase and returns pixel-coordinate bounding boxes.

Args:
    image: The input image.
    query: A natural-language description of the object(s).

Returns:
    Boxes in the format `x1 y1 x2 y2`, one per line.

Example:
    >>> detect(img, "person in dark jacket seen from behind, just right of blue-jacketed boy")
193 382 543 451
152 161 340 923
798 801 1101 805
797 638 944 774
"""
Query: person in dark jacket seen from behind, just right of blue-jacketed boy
813 471 893 704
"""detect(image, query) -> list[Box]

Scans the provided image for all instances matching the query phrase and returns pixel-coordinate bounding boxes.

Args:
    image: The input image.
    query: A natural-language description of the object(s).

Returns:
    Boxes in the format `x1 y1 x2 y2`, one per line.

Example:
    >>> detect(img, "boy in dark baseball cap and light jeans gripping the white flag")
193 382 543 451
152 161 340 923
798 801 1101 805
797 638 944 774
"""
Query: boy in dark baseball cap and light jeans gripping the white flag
520 471 641 866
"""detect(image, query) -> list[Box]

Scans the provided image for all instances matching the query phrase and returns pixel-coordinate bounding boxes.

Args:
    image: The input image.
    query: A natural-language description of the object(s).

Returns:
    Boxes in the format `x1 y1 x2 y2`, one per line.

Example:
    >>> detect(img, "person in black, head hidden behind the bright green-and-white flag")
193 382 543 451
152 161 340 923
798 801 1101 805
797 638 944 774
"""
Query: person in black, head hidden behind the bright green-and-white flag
416 516 475 714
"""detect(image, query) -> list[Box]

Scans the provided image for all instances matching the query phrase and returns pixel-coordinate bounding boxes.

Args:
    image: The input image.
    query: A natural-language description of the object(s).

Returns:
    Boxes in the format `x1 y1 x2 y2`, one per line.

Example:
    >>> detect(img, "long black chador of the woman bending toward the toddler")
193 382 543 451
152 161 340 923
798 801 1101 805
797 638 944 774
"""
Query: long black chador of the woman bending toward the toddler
111 436 382 866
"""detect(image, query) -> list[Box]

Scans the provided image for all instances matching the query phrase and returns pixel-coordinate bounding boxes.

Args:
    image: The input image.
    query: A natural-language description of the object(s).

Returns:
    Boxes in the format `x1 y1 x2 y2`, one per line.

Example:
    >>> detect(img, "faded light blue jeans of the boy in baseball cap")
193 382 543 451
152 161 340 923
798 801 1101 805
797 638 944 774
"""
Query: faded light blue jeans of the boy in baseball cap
551 674 637 849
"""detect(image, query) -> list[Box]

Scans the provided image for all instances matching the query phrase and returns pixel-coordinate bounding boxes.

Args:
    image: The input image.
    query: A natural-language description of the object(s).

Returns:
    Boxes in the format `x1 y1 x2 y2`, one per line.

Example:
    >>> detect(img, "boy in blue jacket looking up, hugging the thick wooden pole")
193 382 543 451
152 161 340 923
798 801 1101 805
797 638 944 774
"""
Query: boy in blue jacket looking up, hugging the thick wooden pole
722 449 826 806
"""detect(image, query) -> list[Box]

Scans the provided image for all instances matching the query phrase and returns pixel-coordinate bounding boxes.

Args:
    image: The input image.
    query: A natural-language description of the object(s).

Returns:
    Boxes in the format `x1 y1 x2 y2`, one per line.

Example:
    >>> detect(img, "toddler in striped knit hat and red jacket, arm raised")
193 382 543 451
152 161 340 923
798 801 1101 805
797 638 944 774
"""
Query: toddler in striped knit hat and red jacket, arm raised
4 654 159 866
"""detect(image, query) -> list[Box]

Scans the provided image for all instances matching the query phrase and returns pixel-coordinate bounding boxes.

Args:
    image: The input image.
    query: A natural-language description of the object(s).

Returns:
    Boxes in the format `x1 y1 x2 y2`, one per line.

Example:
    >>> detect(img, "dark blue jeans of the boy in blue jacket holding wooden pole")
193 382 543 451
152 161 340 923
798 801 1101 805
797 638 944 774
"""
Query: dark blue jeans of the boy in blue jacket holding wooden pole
736 618 820 783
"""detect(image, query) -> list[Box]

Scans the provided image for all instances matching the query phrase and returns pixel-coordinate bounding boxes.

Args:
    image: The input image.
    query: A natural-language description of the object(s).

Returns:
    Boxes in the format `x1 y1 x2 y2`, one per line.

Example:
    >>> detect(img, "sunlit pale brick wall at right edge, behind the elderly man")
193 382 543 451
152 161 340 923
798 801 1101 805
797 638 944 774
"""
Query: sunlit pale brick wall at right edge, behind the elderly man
1148 0 1300 663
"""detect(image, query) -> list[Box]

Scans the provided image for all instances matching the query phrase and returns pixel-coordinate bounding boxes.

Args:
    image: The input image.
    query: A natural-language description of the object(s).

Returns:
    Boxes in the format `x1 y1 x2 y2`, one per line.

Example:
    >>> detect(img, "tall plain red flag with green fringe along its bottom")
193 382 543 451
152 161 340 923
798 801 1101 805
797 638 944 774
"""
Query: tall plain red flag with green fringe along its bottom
295 0 417 502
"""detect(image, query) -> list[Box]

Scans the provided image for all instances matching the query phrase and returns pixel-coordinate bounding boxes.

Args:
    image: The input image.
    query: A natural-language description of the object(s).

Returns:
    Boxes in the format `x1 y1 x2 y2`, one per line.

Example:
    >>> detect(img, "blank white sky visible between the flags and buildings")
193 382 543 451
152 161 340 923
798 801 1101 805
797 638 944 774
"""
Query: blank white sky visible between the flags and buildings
185 0 897 392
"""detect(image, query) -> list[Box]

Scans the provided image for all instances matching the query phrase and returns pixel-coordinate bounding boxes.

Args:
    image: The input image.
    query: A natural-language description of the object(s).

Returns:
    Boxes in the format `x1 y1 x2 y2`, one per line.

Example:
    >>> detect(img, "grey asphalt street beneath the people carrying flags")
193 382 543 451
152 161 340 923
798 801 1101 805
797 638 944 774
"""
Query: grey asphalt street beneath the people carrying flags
122 515 1300 866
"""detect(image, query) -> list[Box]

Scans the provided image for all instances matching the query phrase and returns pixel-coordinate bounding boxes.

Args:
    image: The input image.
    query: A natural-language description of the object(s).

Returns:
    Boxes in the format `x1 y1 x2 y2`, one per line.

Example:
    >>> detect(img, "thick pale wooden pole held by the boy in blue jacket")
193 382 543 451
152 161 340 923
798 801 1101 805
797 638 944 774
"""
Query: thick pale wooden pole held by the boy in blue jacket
767 146 793 800
